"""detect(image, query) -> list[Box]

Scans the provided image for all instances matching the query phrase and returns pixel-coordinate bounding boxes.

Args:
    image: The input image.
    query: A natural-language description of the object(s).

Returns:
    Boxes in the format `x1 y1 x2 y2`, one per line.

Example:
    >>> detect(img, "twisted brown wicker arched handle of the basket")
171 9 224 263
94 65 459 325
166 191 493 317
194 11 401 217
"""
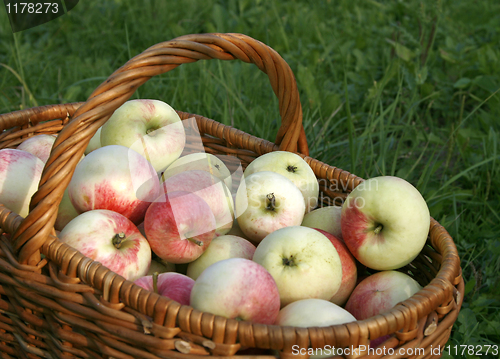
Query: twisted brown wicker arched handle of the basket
13 33 308 264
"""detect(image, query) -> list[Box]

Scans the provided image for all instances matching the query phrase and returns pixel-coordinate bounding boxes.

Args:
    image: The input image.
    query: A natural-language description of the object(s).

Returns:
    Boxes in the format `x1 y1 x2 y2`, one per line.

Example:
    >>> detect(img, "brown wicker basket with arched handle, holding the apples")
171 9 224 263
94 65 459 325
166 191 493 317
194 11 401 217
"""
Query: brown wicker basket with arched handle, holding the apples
0 34 463 359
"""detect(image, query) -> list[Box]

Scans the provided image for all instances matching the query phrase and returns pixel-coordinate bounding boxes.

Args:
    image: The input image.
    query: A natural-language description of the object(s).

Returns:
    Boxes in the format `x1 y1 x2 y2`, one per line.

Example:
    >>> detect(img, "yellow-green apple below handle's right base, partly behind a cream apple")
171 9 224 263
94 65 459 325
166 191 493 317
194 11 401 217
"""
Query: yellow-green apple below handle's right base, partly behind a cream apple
244 151 319 212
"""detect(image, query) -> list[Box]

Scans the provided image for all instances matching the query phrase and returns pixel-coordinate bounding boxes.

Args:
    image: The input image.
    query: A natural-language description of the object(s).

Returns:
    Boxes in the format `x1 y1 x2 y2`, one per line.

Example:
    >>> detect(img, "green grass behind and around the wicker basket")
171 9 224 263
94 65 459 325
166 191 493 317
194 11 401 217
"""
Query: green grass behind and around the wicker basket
0 0 500 358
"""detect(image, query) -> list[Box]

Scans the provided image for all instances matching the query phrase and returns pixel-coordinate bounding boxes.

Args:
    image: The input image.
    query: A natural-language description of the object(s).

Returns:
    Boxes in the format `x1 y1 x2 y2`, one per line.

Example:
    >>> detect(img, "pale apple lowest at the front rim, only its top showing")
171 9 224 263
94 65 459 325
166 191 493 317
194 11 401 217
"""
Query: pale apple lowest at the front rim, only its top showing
275 298 356 359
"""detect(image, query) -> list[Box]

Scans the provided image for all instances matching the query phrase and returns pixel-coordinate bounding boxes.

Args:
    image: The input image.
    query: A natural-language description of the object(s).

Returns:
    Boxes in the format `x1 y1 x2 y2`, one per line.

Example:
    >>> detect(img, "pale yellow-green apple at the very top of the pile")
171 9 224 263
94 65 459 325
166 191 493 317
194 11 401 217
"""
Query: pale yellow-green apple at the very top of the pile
101 100 186 172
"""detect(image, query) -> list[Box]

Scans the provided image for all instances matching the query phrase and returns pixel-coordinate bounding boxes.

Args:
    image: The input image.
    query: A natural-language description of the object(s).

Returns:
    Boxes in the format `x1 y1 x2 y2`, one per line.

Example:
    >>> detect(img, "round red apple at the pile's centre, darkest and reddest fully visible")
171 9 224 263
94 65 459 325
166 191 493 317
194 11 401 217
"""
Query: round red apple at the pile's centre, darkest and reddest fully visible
144 191 215 263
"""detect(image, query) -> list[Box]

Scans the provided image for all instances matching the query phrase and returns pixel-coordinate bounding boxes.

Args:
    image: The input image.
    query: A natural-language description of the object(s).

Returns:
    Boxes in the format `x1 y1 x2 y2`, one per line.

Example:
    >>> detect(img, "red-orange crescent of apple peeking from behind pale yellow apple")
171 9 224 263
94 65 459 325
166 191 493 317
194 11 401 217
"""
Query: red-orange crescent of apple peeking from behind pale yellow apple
316 228 358 305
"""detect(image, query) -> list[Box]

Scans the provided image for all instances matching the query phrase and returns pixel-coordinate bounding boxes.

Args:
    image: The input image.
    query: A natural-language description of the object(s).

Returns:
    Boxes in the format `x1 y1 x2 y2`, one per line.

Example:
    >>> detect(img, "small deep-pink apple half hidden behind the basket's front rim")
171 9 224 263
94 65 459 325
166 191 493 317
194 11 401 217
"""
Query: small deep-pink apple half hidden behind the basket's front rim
134 272 194 305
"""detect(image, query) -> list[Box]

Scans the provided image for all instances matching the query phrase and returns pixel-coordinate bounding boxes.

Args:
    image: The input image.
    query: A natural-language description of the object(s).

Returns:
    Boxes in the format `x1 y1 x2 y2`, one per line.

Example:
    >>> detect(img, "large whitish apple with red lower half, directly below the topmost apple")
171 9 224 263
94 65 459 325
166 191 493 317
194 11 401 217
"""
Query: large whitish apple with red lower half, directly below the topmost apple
68 145 160 224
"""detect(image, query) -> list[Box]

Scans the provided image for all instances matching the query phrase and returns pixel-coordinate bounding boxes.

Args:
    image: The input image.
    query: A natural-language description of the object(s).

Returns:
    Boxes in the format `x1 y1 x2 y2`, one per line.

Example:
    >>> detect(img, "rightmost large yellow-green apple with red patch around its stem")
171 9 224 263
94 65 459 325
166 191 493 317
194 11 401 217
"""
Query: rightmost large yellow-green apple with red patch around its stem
341 176 430 270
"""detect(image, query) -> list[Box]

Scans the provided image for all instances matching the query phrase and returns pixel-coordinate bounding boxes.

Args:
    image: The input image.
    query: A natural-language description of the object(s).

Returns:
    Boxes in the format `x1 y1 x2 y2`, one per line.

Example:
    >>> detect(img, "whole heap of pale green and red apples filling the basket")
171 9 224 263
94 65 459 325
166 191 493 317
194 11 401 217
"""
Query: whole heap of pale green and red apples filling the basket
0 100 430 352
